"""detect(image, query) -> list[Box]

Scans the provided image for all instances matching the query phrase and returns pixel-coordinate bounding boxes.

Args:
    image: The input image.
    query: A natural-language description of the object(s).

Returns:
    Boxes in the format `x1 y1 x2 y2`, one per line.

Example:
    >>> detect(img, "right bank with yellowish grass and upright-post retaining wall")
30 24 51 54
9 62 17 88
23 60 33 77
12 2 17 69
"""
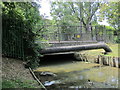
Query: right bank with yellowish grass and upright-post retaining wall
75 44 120 68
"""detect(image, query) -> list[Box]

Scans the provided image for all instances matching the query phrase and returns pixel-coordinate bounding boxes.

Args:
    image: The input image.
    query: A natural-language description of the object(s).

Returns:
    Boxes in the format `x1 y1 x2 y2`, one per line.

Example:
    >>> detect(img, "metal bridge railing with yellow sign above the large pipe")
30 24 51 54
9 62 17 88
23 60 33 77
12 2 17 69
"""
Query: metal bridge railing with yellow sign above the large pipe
38 25 116 42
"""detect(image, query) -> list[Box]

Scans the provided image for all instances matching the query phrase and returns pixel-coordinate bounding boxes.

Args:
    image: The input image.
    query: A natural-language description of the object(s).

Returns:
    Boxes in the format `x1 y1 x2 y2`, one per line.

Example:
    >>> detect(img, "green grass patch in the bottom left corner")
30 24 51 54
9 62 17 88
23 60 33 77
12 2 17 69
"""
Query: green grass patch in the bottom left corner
2 79 38 88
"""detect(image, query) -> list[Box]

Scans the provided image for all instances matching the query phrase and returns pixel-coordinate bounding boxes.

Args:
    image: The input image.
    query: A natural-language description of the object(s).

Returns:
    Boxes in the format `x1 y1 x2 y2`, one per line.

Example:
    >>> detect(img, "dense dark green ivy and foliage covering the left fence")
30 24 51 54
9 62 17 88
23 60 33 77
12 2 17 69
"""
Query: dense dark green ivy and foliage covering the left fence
2 2 43 68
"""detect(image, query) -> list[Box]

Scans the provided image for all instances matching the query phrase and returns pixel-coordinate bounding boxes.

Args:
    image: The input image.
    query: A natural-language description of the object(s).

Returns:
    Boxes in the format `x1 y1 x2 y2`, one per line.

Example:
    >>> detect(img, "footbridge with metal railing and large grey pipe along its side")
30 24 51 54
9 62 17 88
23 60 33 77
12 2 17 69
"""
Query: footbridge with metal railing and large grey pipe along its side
37 25 113 55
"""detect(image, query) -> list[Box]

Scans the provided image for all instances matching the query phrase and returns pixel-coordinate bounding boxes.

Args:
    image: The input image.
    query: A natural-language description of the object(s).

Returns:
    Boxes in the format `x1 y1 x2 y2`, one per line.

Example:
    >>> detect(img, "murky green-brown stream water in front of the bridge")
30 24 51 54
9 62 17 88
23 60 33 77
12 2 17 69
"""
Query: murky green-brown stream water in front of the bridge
35 61 120 88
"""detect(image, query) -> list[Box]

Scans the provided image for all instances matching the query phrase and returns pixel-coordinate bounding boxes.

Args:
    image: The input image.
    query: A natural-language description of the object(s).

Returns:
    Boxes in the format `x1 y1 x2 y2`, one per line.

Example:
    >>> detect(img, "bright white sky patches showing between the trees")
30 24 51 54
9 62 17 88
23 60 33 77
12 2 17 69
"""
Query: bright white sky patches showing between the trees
39 0 109 26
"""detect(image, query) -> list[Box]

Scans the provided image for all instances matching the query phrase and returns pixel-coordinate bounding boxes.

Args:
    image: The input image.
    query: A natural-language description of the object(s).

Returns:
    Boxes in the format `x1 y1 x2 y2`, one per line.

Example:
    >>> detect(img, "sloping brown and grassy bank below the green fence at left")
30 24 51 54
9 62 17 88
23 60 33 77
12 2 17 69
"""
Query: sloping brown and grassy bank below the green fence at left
2 58 41 88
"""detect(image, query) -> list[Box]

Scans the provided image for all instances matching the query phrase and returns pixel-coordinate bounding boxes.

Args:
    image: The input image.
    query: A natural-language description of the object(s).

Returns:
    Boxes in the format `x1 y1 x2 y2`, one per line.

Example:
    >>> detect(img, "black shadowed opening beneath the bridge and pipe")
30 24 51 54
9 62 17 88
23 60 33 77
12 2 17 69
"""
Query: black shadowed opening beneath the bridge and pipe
40 54 75 66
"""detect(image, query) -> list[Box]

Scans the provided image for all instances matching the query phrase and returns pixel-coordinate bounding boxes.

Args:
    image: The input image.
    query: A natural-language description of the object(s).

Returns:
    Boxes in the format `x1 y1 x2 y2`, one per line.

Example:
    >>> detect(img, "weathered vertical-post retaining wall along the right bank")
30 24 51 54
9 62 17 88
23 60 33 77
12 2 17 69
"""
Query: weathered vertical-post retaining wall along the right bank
74 53 120 68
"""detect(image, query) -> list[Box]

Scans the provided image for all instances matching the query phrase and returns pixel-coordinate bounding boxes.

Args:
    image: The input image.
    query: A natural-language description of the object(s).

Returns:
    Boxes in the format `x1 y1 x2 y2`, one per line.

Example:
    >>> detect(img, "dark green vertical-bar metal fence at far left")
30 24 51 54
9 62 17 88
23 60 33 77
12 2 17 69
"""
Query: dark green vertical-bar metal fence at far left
2 18 24 59
